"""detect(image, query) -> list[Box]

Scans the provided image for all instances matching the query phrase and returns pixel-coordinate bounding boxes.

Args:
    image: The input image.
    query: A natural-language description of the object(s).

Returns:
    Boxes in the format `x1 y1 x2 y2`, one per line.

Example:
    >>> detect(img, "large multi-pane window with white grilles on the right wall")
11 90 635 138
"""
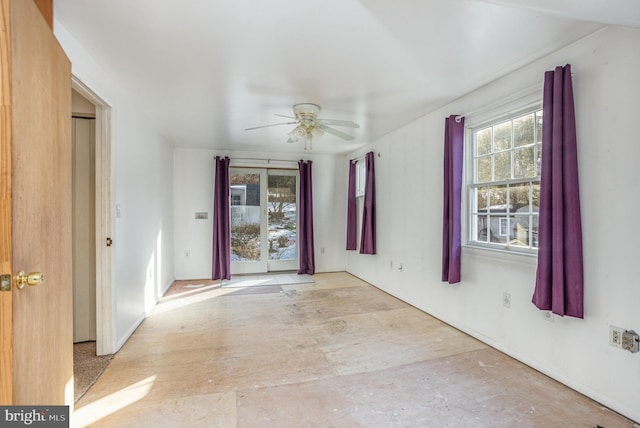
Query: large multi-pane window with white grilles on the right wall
467 109 542 252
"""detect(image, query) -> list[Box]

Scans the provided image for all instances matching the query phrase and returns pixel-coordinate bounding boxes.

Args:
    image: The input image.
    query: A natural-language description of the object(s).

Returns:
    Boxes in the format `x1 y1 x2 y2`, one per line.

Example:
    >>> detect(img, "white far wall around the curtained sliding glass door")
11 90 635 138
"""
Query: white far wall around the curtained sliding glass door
174 149 346 279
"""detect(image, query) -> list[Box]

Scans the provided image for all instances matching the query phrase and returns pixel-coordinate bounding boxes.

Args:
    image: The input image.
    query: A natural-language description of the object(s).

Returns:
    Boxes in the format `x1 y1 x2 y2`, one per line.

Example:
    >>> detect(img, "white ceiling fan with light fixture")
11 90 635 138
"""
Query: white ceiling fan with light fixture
245 103 360 150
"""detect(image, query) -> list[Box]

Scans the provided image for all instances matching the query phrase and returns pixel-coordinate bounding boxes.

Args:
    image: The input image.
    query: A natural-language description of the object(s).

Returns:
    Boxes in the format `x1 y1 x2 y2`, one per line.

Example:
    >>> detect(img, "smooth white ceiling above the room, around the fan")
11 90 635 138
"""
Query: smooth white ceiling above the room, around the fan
54 0 640 153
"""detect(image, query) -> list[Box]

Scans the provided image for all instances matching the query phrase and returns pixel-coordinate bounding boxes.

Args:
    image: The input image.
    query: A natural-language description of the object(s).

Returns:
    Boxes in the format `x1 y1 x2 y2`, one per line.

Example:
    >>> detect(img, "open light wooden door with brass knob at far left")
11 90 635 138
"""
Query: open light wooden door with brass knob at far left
0 0 73 405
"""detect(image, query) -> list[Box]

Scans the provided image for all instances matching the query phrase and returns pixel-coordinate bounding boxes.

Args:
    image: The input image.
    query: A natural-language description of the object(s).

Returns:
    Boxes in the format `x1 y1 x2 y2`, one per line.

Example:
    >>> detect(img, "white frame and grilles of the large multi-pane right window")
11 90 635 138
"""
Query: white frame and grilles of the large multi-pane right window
462 98 542 256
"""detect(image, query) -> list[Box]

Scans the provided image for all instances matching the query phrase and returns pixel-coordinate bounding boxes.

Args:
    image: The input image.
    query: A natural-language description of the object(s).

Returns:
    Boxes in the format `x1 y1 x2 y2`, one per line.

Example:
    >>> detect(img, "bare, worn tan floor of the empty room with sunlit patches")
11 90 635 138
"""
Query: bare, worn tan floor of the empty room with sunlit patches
72 273 633 428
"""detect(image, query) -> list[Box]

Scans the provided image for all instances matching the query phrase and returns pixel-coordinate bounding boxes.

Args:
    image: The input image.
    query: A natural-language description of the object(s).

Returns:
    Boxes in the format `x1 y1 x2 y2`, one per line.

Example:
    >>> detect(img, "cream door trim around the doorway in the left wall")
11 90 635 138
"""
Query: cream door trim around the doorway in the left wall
71 75 116 355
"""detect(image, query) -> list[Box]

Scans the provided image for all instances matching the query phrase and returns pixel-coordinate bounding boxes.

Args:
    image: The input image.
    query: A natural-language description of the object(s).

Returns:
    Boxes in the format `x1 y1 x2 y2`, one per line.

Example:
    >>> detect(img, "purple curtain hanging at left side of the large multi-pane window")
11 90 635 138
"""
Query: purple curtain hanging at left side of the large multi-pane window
442 115 464 284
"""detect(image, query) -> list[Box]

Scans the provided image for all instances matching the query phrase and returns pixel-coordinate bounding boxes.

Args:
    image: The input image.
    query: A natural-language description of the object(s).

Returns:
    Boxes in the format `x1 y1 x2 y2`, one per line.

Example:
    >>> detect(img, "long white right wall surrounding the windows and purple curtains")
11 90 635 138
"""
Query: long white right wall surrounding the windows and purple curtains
347 28 640 421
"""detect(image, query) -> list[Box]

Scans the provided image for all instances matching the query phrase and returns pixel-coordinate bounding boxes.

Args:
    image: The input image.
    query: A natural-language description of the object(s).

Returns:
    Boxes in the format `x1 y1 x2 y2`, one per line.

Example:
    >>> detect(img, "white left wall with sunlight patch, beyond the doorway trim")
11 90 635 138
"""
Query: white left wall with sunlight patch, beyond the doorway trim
54 21 174 352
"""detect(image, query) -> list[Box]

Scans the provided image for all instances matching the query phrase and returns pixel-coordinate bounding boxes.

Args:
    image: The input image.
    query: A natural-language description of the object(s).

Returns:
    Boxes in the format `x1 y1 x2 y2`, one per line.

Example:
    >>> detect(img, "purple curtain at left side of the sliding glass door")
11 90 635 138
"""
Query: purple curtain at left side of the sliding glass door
212 156 231 279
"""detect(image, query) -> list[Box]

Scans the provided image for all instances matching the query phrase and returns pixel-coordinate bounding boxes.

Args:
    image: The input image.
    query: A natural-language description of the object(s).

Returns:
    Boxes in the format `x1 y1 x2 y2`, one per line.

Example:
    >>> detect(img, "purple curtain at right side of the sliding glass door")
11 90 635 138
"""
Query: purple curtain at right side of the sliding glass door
298 160 316 275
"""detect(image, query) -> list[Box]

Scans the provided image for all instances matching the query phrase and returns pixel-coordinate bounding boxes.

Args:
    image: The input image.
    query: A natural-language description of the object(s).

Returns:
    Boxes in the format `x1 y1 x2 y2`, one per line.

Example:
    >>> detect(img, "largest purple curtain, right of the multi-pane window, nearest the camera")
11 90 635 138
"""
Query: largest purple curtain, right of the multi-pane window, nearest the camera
532 64 584 318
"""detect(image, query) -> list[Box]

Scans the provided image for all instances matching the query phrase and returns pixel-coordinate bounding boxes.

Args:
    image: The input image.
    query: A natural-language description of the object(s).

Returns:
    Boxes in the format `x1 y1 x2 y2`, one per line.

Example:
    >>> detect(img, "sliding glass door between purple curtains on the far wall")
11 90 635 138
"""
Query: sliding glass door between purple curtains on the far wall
229 168 298 274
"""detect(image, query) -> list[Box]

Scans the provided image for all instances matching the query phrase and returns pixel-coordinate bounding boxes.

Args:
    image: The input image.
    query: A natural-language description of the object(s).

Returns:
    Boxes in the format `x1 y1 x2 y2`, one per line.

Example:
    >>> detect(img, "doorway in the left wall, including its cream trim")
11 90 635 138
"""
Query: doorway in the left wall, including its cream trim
71 76 115 356
